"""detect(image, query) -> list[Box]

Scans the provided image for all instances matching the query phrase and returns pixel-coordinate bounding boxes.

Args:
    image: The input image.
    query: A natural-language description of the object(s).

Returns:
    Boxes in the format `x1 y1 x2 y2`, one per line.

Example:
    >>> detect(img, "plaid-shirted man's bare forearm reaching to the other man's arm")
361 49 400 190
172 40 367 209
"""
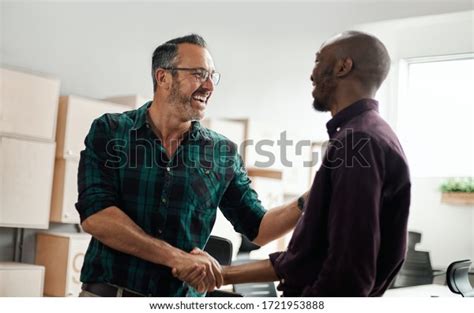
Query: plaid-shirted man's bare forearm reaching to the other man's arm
253 192 308 246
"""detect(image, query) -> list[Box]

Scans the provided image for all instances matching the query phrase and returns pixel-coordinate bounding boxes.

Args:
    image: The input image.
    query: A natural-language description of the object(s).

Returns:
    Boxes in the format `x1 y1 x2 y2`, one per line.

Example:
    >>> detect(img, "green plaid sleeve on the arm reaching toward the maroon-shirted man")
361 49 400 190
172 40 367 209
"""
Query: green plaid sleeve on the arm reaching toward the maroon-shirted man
219 154 266 240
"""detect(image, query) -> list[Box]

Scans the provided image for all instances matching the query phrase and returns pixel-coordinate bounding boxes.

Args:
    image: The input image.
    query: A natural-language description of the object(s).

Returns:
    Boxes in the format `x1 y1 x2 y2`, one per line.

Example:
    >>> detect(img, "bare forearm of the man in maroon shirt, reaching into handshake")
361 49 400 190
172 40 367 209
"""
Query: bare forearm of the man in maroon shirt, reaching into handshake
223 260 278 285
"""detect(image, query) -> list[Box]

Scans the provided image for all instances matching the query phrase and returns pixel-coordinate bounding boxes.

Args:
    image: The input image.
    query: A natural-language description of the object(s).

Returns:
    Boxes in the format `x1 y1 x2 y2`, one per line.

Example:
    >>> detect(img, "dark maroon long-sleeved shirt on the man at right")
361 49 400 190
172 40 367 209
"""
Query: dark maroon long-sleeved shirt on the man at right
270 99 410 297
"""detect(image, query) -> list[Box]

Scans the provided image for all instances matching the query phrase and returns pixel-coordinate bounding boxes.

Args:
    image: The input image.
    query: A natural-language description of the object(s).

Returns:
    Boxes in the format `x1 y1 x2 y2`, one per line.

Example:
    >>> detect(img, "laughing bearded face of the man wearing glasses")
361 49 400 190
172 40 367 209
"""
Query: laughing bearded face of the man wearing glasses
167 44 214 121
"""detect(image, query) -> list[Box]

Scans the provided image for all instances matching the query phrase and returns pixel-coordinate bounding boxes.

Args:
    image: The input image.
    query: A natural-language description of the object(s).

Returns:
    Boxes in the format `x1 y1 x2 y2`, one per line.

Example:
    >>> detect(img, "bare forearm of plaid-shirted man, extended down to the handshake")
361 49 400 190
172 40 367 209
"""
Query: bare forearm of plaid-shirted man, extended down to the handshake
82 206 185 267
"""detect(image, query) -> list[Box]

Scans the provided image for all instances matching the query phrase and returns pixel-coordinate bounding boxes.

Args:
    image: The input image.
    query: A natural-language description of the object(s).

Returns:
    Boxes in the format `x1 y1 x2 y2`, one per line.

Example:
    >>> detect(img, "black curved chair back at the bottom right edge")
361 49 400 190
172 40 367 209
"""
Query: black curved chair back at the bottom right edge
446 260 474 297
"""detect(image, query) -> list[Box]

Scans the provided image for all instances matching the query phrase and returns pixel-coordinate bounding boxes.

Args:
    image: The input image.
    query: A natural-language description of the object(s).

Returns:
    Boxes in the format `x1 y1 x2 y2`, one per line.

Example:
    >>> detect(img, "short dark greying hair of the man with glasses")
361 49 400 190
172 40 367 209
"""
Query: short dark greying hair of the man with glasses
151 34 207 92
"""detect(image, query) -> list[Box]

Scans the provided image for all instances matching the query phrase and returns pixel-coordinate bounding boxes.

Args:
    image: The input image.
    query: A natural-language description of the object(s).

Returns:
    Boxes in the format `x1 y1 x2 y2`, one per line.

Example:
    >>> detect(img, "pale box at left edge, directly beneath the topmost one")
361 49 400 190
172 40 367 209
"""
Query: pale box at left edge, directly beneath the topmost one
0 136 55 229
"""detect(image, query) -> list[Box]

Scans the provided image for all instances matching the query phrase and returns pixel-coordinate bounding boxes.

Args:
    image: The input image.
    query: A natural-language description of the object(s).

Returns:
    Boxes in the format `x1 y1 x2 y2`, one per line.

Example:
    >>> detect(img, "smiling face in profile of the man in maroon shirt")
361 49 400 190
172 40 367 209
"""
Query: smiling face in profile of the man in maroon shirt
310 46 337 112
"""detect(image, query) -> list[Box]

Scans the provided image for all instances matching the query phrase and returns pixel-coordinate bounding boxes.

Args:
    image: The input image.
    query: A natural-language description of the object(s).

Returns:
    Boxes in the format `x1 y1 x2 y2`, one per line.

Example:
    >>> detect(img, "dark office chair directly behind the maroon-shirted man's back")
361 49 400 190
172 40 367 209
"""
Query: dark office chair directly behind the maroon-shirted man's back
390 232 445 288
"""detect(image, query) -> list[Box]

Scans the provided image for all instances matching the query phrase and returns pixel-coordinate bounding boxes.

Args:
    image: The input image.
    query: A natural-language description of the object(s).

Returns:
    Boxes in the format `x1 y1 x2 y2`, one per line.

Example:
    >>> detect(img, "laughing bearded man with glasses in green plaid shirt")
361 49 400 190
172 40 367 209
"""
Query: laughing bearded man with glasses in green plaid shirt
76 35 304 296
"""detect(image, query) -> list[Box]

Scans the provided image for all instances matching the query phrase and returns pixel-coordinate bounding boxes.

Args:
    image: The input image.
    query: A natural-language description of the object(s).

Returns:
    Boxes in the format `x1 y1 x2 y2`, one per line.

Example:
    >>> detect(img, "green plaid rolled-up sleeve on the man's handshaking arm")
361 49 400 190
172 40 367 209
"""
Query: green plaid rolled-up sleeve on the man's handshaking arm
76 115 118 223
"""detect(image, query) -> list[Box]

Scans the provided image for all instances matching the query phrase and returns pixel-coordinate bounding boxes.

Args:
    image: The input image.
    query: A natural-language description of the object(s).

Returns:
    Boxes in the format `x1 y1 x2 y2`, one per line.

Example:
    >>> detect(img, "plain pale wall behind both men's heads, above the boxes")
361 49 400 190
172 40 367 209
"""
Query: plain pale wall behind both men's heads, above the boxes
0 0 472 140
